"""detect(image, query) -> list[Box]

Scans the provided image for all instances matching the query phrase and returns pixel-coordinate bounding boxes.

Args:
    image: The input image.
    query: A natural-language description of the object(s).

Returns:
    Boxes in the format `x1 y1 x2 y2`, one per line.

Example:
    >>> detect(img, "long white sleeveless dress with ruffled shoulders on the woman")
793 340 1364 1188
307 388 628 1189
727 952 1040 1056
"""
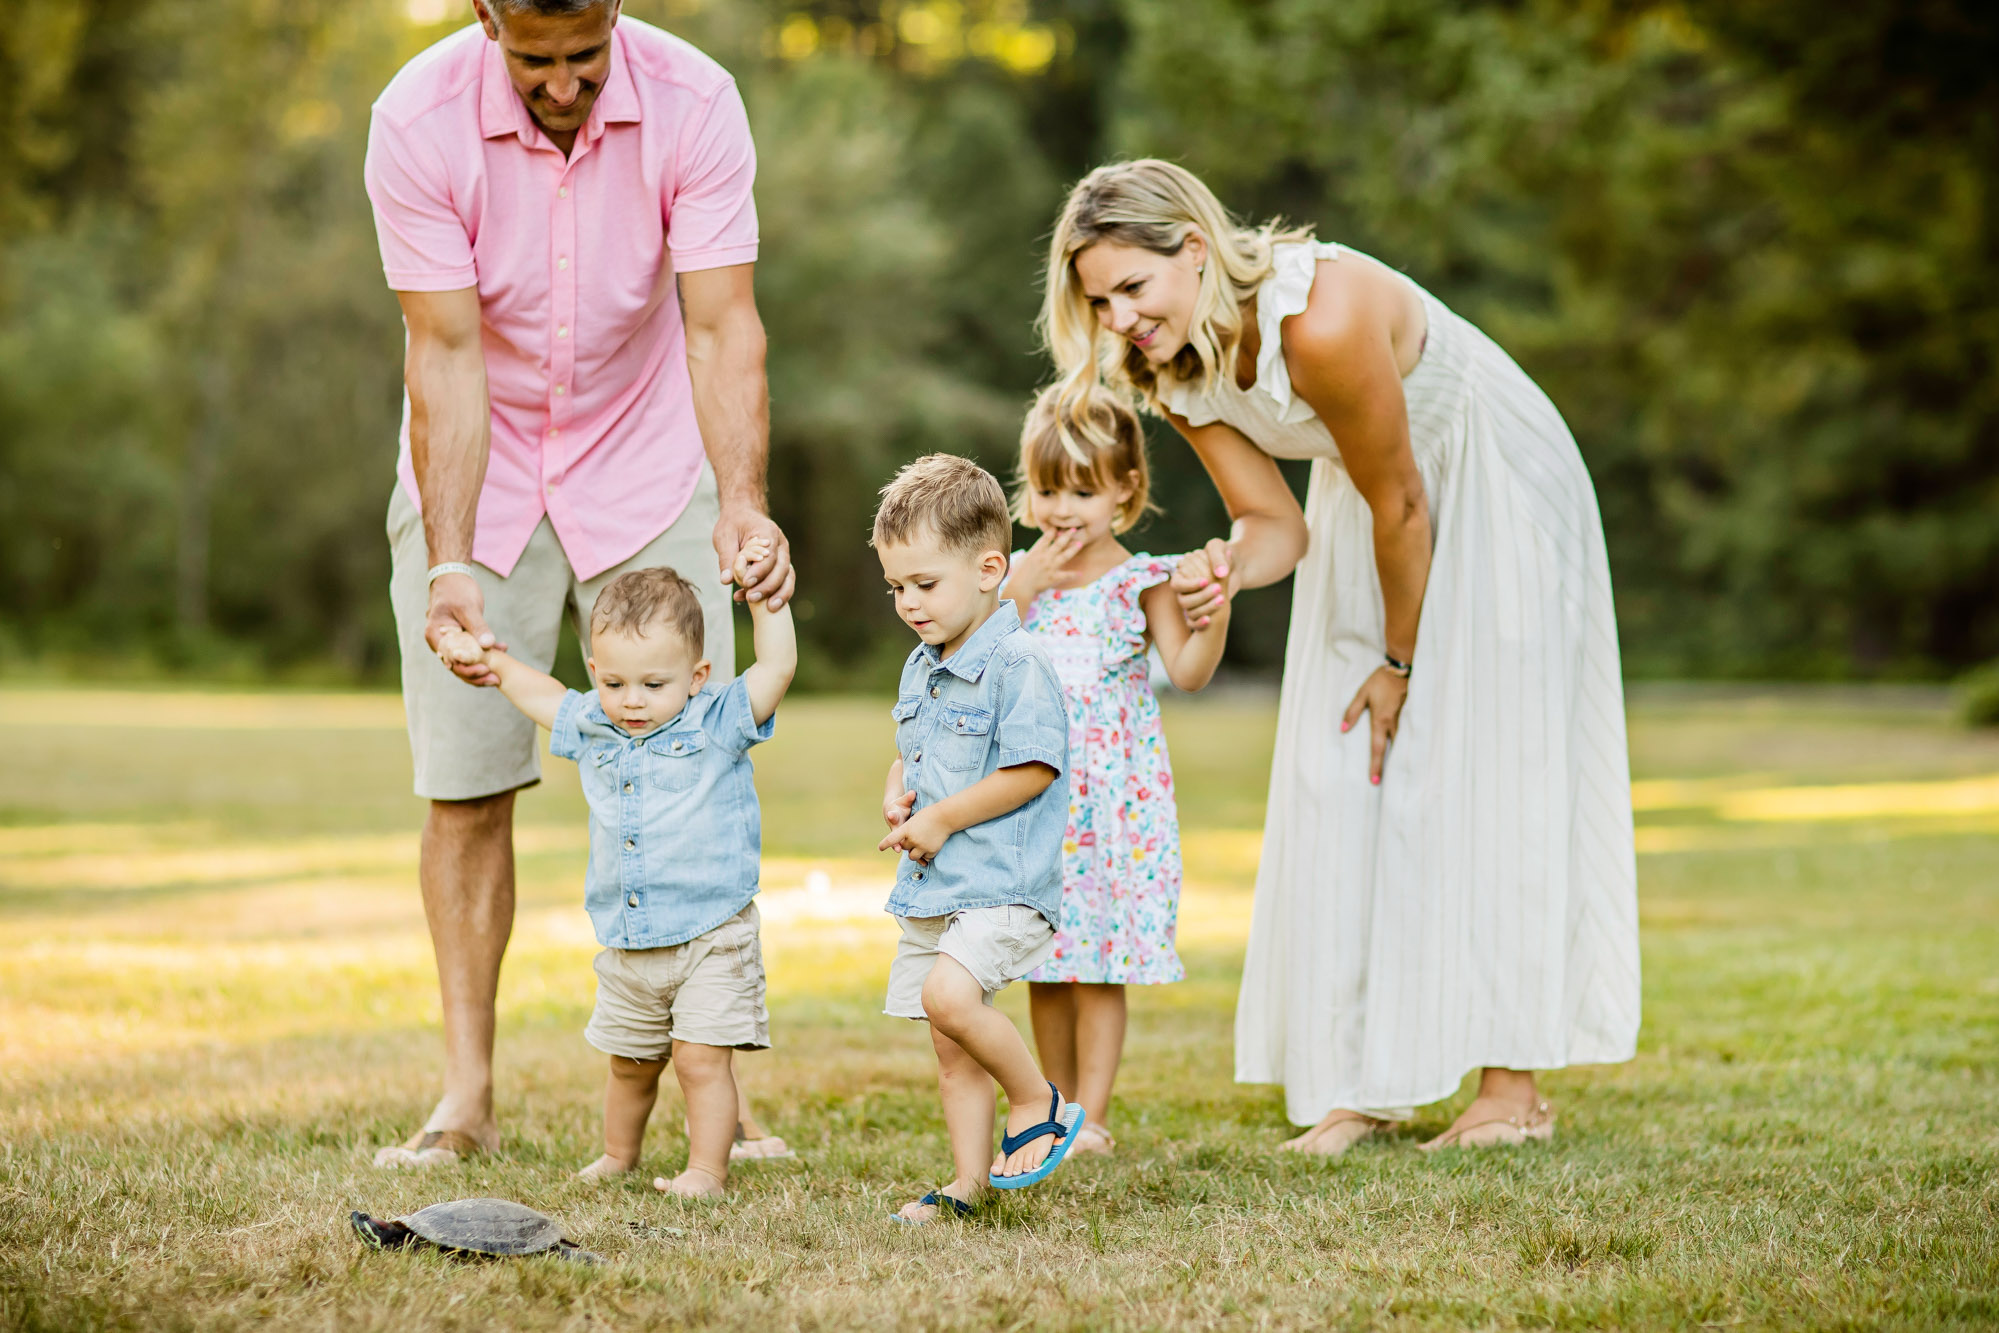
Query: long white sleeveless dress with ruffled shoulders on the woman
1161 244 1639 1125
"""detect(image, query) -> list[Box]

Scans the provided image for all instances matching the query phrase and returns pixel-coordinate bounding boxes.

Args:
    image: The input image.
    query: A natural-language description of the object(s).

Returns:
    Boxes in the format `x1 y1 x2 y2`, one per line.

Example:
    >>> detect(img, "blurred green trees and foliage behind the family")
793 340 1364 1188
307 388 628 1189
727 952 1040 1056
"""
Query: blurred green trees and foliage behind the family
0 0 1999 683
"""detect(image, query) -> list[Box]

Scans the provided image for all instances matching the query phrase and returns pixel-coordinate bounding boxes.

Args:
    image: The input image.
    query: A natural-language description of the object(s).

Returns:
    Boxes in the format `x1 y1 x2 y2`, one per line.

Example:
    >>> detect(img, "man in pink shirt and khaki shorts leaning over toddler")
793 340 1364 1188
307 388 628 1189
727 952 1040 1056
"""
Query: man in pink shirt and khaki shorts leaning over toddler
366 0 792 1165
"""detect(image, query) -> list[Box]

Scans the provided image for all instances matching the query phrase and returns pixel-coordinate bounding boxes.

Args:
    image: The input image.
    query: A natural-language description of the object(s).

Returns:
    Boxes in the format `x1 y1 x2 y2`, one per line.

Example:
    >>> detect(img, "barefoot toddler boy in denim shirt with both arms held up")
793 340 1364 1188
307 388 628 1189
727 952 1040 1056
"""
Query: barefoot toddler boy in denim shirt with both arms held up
442 542 798 1197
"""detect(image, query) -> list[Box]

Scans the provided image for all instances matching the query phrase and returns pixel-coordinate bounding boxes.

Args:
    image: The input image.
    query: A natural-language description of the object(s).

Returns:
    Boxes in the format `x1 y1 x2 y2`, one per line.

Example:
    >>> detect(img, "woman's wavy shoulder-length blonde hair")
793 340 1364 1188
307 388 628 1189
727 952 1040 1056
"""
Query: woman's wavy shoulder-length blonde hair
1039 158 1311 453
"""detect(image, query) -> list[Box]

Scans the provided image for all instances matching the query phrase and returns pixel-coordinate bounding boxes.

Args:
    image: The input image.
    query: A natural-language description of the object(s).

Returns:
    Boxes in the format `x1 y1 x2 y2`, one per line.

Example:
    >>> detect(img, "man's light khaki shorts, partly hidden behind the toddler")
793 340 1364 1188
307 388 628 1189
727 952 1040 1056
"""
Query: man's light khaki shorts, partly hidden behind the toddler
388 473 736 801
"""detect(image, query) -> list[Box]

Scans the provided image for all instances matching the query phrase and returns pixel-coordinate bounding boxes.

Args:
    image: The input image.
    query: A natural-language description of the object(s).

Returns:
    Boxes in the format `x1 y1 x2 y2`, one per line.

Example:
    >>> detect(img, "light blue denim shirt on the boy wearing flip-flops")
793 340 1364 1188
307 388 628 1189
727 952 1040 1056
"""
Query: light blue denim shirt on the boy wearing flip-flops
888 602 1069 923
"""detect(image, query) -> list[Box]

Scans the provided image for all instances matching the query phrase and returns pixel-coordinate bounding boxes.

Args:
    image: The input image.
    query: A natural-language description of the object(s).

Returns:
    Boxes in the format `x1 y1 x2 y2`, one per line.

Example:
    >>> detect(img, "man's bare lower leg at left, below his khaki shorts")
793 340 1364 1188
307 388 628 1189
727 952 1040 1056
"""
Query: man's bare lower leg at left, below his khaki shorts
376 791 514 1165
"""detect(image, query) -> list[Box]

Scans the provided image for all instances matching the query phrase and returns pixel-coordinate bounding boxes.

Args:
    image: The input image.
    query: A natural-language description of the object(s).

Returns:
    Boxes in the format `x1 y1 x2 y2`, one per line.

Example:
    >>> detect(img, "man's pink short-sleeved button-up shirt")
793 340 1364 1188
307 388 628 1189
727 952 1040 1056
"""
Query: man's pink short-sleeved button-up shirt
366 18 758 578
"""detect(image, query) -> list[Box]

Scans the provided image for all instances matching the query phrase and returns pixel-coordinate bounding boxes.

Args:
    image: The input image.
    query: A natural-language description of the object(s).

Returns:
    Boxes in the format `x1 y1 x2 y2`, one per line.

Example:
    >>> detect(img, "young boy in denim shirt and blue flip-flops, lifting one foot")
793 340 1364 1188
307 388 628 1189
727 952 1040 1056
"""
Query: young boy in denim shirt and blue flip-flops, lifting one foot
872 454 1083 1225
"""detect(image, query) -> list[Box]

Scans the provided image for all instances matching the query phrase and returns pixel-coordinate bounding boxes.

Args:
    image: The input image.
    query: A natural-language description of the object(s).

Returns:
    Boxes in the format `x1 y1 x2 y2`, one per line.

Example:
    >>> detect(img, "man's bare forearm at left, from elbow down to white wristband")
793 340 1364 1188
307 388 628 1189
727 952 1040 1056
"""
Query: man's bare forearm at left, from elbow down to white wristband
404 342 492 566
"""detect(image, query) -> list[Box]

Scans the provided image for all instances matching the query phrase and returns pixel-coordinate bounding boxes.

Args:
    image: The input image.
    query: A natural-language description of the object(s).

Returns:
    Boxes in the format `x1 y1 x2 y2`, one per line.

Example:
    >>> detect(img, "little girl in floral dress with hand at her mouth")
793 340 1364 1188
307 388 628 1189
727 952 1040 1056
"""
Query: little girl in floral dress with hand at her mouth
1001 390 1227 1153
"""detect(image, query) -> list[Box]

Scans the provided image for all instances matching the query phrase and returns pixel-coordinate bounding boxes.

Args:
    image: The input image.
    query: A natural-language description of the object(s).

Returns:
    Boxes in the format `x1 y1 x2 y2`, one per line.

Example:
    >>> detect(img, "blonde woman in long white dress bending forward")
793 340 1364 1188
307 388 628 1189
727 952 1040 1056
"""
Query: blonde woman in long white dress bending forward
1043 160 1639 1153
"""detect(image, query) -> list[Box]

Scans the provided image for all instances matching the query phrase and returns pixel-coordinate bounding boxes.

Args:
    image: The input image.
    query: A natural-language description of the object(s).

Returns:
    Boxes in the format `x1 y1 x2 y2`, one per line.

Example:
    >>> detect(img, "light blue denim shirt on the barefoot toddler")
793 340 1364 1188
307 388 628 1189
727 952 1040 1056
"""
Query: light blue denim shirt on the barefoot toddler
548 675 778 949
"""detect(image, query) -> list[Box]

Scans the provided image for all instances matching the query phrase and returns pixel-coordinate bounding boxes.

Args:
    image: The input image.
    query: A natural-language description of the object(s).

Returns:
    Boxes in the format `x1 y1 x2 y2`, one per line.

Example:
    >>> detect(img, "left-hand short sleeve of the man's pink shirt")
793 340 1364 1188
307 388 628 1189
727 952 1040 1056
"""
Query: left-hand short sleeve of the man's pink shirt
362 110 480 292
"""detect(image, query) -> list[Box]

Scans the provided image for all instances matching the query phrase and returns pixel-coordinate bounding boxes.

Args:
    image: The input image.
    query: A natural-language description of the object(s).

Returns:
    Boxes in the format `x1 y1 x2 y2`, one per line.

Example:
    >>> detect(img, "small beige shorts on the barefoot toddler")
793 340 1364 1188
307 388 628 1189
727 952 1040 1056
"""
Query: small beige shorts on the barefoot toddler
584 903 770 1061
